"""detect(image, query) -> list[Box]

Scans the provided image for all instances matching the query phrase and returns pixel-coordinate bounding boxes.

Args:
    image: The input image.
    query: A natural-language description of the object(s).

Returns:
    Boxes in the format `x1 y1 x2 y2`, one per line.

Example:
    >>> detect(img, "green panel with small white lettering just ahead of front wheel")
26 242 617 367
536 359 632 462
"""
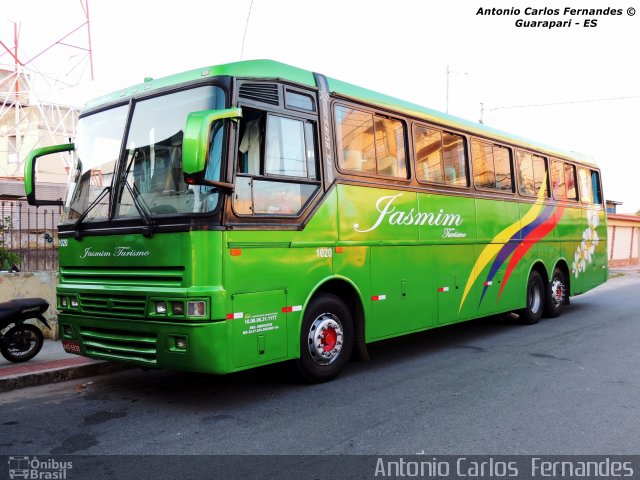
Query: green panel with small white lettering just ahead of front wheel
229 290 287 368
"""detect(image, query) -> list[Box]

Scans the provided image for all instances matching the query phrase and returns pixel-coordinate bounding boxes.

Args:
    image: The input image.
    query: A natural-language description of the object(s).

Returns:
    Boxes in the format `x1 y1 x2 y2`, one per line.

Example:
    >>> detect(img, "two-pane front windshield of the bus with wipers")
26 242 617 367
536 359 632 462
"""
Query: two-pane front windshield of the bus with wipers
61 86 225 222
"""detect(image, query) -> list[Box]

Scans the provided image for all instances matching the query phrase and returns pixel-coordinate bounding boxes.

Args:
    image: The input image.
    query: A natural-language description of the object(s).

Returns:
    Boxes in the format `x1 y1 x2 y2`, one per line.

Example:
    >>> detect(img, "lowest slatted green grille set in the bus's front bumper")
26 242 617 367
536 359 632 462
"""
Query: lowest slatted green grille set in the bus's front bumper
80 327 158 365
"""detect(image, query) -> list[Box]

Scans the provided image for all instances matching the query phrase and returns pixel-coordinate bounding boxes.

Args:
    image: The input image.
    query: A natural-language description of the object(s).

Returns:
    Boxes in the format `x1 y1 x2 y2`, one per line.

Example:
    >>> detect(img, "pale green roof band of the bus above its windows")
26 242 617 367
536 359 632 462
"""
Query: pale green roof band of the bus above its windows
84 60 595 165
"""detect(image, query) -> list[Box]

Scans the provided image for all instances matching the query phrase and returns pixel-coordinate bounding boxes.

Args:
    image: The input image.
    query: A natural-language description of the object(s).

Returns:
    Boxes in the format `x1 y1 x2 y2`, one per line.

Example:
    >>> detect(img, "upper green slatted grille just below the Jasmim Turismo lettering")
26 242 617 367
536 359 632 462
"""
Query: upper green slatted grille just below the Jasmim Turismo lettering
60 266 184 287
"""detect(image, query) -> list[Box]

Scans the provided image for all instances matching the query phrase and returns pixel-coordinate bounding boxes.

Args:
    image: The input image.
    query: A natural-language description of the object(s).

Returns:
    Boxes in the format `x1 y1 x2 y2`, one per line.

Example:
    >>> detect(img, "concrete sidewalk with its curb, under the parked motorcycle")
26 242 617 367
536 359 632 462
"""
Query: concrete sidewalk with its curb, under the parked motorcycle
0 340 131 392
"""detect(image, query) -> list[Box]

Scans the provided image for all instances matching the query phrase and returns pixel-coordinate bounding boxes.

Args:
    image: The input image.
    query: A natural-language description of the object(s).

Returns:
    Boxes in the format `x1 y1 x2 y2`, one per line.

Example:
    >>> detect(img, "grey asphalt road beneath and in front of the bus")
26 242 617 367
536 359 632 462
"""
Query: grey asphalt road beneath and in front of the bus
0 273 640 455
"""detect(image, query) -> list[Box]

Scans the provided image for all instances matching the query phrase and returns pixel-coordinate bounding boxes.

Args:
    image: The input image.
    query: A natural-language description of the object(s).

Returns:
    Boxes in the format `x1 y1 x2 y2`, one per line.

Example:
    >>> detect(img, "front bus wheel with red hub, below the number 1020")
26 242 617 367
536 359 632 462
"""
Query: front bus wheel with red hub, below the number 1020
297 293 354 383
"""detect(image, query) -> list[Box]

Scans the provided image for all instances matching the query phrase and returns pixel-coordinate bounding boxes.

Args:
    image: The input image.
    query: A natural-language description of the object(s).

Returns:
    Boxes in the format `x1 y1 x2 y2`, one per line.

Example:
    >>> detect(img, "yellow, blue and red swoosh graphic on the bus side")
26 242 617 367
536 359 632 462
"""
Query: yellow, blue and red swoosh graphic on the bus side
458 185 564 312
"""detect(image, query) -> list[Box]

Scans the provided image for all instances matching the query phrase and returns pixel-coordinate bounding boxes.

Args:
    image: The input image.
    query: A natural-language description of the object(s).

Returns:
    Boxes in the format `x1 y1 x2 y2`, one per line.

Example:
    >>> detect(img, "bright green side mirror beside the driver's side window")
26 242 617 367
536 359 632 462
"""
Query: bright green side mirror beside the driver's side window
182 108 242 178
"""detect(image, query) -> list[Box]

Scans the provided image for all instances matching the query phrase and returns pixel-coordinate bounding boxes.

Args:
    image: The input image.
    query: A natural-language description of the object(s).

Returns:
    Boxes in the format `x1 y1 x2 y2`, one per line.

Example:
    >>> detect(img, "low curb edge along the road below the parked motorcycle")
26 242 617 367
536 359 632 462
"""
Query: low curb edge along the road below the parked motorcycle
0 358 132 393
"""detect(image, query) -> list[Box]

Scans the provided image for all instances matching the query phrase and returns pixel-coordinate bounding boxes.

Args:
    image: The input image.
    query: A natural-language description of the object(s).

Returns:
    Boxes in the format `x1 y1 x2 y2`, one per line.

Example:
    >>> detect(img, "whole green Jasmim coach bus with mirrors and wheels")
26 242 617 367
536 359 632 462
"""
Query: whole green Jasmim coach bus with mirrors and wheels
25 60 608 382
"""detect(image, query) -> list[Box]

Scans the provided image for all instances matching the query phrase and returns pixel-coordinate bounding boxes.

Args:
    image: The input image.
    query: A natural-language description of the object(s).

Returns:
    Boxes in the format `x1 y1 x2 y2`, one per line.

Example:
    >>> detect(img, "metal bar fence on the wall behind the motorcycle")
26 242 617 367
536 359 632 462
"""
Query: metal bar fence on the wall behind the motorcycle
0 201 61 272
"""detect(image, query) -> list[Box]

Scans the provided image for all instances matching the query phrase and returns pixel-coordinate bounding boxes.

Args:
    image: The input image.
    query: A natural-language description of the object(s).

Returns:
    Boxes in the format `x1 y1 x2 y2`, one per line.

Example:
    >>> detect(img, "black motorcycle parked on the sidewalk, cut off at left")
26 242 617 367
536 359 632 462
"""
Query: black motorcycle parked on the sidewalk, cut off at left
0 298 51 363
